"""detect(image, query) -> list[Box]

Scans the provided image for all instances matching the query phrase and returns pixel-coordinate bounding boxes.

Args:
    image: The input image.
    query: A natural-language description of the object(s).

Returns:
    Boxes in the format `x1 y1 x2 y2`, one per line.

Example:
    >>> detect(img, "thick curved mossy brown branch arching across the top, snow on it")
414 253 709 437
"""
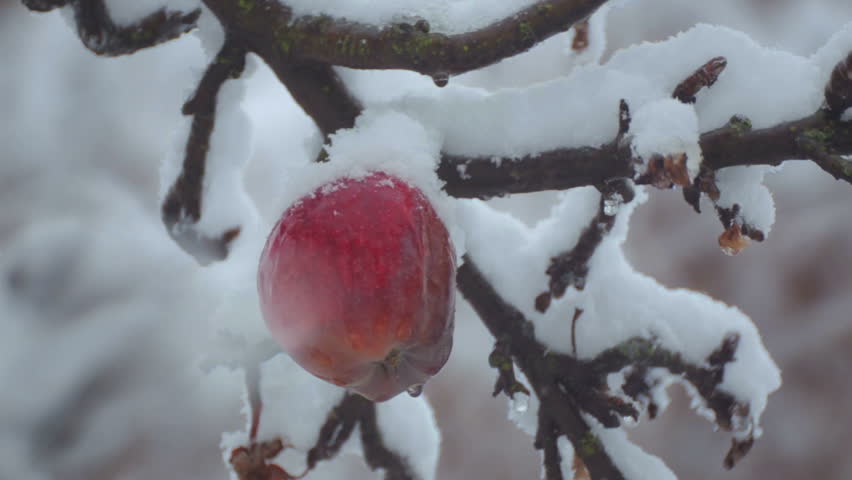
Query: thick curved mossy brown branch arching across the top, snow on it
204 0 606 81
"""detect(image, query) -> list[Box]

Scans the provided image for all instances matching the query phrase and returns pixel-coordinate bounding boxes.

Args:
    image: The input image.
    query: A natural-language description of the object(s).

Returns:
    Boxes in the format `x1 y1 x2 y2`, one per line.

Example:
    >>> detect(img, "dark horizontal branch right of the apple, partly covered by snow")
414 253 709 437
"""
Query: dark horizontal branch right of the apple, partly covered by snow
437 112 852 198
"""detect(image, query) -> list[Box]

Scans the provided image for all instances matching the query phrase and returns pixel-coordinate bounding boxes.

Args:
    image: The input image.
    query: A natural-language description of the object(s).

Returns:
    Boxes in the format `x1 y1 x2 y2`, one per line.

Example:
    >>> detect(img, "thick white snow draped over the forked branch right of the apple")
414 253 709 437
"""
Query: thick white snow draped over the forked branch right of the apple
461 183 780 450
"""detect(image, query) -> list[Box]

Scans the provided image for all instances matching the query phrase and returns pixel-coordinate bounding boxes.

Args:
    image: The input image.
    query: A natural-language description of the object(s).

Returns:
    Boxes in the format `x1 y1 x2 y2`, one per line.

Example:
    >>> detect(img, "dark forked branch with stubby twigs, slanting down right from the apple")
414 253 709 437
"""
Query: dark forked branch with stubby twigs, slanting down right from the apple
457 256 751 479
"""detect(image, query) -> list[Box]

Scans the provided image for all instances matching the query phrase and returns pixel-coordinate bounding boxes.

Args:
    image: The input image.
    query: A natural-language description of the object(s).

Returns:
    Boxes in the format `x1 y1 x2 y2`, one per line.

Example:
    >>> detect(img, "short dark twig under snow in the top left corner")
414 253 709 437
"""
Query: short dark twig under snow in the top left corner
23 0 201 57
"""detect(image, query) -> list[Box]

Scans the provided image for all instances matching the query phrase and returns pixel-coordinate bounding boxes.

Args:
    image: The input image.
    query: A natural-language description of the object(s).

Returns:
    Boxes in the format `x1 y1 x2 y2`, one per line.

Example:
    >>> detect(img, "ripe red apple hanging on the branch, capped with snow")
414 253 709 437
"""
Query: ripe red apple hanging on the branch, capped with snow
258 172 456 402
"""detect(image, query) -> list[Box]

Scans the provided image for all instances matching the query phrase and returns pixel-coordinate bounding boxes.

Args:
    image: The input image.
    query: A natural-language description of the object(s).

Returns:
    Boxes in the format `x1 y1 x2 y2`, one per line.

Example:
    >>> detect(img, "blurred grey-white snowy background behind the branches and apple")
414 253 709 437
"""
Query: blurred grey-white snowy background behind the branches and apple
0 0 852 480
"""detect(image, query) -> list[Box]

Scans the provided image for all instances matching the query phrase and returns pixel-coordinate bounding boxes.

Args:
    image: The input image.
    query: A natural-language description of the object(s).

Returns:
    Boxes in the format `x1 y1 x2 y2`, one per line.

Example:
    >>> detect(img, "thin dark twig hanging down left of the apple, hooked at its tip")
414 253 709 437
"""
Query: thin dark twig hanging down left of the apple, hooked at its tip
161 38 246 265
